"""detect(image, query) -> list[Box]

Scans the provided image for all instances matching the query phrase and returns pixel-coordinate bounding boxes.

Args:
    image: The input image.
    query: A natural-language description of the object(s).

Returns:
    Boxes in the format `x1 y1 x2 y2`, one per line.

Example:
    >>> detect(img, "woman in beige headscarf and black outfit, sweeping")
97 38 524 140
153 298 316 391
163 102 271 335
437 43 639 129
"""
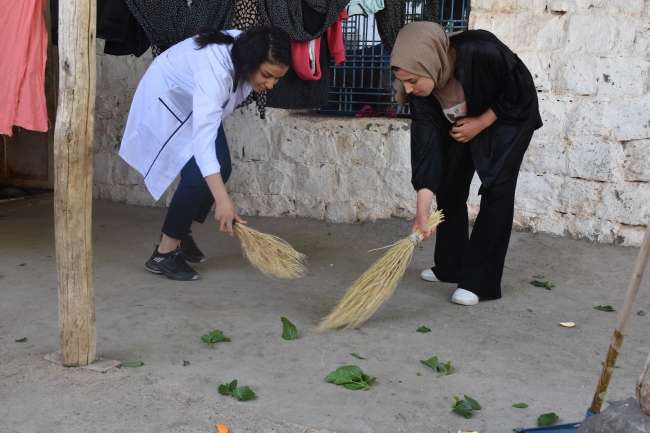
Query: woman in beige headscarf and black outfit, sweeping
391 22 542 305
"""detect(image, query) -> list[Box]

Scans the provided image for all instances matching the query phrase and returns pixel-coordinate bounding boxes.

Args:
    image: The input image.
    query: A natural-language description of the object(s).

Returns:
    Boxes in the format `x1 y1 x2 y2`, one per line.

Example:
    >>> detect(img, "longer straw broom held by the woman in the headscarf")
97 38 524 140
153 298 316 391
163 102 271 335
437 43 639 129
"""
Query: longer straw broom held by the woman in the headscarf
316 211 443 331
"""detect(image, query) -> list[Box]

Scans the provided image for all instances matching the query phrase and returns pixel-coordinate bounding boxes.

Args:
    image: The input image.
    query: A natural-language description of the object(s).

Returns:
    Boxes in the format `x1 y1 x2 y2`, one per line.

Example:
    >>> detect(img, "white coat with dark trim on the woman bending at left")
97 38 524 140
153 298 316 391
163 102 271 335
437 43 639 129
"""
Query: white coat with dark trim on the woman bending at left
120 30 251 200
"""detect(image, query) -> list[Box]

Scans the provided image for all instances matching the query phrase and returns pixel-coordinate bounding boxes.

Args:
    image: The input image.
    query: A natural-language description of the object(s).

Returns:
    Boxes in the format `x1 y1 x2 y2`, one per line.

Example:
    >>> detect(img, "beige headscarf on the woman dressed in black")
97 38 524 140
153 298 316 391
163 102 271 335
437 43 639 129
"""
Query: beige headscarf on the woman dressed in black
390 21 453 106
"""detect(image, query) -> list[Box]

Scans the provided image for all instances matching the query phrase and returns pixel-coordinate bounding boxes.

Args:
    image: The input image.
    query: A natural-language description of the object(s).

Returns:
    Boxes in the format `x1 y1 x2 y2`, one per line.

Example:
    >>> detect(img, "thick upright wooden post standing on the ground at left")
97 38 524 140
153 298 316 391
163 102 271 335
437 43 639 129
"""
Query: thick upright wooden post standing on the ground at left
54 0 97 367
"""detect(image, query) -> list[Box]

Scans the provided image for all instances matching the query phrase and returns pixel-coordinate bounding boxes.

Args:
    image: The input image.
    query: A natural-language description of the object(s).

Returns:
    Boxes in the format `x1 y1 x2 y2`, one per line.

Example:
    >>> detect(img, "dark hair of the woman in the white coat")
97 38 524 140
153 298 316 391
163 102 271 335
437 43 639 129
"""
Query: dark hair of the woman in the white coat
194 27 291 84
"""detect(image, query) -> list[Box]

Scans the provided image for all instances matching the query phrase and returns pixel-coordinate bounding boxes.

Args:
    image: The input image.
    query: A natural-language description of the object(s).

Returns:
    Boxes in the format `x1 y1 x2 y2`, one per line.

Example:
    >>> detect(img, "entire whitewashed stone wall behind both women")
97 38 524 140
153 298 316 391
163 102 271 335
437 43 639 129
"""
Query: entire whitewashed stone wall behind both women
95 0 650 246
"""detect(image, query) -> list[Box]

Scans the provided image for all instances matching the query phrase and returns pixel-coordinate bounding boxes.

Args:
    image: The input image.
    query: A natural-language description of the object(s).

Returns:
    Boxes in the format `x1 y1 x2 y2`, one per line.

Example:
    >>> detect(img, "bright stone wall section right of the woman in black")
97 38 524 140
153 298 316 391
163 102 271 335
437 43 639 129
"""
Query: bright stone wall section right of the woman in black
470 0 650 245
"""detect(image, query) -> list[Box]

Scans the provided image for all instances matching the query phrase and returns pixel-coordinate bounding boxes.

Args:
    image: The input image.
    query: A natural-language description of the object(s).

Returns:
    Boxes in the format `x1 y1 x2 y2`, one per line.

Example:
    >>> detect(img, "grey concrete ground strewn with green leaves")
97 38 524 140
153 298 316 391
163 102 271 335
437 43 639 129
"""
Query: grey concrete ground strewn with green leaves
0 196 650 433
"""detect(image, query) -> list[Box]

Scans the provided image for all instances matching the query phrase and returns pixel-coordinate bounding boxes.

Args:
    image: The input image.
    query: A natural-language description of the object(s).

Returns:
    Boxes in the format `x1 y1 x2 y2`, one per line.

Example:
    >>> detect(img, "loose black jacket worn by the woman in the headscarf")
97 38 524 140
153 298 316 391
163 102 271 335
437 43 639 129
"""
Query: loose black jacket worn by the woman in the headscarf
409 30 542 196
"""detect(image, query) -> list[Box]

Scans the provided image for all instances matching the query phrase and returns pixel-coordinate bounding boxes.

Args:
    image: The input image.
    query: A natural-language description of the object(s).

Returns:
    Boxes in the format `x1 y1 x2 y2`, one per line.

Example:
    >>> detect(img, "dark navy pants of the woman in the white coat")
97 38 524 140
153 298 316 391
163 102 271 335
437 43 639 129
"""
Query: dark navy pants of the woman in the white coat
162 125 232 240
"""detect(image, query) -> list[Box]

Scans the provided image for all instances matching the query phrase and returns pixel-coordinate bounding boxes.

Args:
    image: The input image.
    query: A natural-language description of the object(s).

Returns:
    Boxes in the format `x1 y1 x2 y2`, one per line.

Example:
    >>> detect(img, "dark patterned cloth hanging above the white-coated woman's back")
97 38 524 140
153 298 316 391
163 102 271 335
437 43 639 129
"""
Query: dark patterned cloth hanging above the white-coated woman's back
126 0 235 49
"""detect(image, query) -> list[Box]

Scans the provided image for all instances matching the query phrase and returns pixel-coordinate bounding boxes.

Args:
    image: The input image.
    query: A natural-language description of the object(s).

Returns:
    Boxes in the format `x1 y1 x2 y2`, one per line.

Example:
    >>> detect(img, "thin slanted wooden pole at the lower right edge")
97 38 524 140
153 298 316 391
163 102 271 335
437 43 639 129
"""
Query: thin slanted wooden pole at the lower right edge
589 220 650 415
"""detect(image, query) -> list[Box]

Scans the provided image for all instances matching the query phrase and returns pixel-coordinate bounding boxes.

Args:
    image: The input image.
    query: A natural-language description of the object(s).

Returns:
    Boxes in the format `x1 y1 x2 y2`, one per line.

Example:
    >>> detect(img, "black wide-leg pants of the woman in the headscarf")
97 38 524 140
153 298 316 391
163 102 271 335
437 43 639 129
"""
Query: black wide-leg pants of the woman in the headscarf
432 144 521 300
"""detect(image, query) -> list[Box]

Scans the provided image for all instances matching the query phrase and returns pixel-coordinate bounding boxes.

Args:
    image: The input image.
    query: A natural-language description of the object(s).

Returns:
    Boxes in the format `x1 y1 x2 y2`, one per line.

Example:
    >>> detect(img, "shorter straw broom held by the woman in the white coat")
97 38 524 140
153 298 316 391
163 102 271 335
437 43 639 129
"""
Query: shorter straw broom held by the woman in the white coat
233 223 307 278
